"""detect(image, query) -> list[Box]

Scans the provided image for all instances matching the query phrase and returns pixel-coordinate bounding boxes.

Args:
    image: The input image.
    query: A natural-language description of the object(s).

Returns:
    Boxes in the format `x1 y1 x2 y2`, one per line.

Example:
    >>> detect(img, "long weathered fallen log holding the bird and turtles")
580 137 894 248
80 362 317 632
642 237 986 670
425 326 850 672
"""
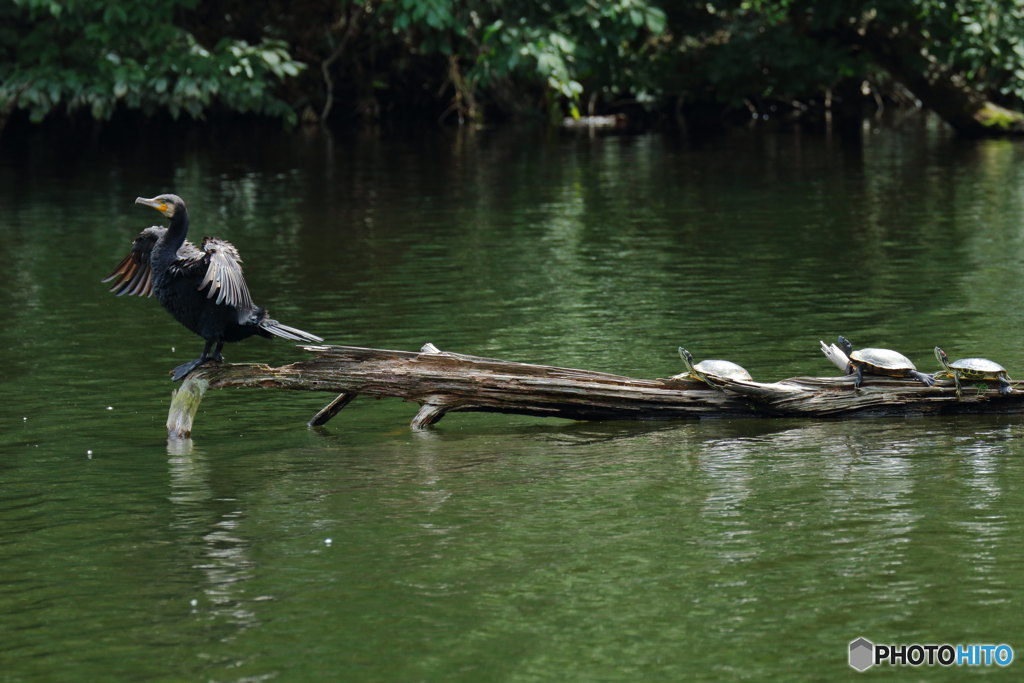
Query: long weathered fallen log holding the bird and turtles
167 344 1024 438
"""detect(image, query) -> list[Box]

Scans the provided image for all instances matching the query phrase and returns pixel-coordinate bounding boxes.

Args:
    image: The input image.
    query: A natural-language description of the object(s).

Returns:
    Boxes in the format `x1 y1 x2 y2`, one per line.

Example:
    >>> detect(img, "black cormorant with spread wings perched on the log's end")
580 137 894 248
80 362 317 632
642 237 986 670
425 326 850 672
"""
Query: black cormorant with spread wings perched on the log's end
102 195 324 381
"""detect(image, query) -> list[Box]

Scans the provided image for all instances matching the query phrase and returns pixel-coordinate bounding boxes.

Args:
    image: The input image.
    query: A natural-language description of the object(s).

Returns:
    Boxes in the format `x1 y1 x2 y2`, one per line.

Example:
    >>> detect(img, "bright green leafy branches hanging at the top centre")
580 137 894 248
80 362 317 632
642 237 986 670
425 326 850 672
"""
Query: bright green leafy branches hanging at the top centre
359 0 666 116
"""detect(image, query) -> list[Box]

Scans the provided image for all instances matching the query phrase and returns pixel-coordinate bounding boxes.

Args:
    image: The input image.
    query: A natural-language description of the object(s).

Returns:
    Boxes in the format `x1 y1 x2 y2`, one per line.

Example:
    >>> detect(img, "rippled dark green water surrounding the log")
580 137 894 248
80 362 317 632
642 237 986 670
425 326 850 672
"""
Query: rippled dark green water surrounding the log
0 129 1024 681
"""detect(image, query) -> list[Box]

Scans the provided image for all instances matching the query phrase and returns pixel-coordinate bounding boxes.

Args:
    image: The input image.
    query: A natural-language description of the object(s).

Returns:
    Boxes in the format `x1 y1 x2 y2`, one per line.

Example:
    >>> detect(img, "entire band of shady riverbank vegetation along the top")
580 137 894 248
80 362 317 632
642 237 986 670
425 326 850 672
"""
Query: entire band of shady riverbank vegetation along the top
6 0 1024 135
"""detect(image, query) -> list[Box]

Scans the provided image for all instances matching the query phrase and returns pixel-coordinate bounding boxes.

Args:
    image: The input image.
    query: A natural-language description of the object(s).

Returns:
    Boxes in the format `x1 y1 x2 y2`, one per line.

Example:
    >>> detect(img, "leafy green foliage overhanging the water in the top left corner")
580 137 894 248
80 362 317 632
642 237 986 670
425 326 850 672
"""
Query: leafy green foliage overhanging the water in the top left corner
0 0 303 122
